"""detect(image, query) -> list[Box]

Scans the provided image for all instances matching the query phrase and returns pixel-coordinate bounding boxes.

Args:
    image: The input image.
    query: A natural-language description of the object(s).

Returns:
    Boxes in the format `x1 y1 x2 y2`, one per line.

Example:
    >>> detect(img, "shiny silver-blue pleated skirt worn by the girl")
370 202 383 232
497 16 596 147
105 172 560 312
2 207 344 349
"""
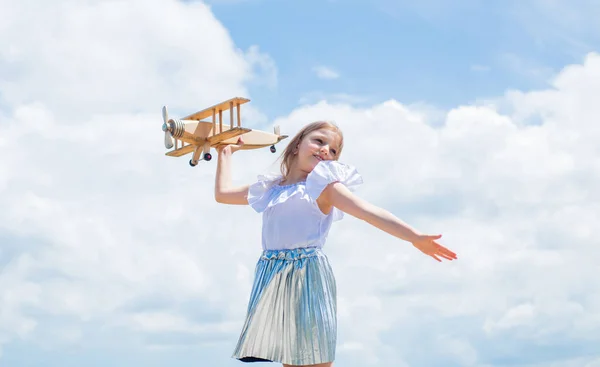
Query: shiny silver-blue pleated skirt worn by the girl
233 248 337 365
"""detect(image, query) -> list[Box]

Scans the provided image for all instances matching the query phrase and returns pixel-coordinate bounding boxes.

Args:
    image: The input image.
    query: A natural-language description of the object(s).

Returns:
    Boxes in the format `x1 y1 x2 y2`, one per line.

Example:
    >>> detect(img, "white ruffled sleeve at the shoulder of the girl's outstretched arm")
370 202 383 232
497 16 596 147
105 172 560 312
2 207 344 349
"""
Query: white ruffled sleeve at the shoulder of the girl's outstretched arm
306 161 363 220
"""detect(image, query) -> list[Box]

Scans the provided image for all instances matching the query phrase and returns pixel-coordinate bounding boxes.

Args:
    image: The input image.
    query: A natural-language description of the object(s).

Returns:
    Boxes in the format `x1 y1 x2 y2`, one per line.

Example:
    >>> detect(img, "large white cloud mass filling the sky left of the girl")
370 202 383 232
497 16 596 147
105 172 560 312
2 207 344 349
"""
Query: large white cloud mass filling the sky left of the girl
0 1 276 364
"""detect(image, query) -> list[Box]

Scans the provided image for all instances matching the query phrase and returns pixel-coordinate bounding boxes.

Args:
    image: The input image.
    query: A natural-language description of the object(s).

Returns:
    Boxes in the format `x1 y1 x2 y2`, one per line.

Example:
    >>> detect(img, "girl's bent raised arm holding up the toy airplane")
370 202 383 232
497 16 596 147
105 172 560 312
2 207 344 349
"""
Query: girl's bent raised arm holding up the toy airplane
215 139 249 205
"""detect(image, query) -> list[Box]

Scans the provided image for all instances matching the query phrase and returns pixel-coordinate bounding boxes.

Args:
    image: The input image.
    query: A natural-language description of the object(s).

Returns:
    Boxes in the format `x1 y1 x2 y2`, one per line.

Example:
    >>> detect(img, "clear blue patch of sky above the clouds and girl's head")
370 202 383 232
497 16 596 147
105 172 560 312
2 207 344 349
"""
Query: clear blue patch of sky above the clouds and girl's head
205 0 593 114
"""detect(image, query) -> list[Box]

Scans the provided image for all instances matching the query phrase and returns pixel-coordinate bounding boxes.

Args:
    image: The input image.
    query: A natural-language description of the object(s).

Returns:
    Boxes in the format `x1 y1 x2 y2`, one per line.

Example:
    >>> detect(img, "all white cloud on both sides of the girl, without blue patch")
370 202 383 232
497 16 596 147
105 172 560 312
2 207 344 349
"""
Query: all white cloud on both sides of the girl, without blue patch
0 1 600 367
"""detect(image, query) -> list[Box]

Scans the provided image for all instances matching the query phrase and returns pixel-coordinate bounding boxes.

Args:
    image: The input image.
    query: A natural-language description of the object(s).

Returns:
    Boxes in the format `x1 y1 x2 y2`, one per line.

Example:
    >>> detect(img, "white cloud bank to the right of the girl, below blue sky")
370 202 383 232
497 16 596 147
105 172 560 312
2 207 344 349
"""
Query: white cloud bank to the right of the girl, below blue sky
272 54 600 366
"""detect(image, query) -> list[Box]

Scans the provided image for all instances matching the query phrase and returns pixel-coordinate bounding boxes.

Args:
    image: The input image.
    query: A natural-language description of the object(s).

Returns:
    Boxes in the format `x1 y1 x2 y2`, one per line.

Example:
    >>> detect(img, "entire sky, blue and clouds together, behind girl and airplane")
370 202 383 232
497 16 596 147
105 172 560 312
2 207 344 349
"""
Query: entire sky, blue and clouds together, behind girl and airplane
0 0 600 367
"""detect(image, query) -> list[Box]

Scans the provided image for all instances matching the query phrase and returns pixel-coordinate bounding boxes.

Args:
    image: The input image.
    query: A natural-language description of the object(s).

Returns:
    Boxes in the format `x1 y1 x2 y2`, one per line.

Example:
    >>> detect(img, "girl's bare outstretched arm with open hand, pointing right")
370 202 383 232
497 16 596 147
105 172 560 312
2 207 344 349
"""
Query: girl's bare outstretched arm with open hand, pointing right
319 182 457 261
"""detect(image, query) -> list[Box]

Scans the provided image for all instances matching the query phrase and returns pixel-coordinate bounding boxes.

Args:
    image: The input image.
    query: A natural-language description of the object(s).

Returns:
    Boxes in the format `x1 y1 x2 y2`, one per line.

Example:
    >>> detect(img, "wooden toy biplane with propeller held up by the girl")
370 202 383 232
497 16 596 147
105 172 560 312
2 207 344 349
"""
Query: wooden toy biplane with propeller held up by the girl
162 97 288 167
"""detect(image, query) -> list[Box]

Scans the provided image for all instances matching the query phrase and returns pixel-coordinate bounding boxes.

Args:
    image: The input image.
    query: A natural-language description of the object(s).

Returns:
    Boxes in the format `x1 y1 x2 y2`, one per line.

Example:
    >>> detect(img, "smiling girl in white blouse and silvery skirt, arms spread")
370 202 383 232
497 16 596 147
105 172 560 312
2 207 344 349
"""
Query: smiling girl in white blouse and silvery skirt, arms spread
215 121 456 367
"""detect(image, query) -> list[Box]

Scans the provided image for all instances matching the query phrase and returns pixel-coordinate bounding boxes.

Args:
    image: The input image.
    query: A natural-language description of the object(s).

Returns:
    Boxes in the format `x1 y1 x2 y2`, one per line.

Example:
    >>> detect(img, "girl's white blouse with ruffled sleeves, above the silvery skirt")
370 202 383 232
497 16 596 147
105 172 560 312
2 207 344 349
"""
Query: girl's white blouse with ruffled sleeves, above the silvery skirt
248 161 363 250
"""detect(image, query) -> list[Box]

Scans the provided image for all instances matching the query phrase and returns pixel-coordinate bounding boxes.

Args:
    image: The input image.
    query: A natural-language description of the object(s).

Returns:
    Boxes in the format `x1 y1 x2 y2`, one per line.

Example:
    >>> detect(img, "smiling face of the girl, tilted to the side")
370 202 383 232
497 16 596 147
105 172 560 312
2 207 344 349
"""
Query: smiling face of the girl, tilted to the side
297 129 340 171
